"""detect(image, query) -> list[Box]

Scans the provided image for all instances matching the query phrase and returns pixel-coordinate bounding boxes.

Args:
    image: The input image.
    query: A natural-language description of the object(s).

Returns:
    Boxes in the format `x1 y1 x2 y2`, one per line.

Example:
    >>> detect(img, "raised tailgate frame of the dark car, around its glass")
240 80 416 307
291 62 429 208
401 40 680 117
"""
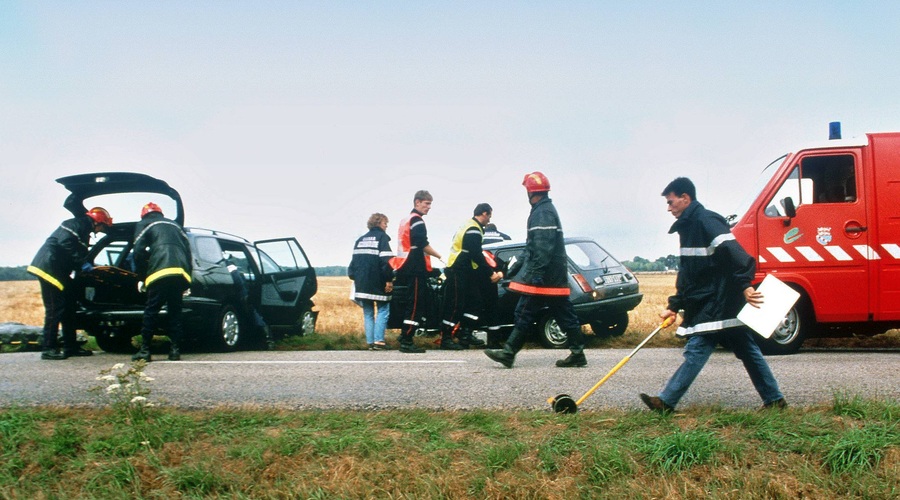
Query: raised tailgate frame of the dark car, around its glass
56 172 184 225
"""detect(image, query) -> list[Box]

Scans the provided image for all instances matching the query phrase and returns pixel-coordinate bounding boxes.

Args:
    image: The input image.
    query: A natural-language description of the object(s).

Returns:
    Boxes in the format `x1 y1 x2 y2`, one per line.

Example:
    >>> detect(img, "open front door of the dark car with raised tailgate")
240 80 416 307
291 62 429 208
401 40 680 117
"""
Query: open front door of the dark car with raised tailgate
254 238 318 325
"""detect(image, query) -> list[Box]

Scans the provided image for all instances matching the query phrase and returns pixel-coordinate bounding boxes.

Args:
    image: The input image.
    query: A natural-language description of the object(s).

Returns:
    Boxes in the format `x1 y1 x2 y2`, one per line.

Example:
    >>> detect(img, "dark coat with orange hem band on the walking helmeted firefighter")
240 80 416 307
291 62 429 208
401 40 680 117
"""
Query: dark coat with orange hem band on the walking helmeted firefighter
509 196 569 297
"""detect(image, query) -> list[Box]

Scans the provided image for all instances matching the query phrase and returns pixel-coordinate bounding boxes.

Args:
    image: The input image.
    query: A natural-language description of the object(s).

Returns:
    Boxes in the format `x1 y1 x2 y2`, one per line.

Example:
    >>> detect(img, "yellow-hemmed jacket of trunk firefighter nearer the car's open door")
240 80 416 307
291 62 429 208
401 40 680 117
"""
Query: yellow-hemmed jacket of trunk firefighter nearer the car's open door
134 212 192 287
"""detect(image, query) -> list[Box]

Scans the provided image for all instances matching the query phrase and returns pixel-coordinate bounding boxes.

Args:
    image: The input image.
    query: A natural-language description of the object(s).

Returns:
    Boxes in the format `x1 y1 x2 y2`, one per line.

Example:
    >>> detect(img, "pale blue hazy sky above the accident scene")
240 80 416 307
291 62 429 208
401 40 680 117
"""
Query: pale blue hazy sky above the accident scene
0 0 900 266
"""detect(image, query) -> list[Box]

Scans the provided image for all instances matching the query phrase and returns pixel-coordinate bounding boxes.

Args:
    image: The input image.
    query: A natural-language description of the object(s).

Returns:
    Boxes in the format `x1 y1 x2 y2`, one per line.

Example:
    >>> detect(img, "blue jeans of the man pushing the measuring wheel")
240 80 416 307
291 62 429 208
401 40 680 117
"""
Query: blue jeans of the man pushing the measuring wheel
659 328 783 408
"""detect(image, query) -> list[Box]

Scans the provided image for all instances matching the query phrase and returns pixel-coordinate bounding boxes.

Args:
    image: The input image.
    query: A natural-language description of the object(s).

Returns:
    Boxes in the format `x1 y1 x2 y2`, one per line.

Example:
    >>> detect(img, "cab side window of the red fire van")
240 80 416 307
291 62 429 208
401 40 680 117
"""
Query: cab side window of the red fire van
766 155 856 217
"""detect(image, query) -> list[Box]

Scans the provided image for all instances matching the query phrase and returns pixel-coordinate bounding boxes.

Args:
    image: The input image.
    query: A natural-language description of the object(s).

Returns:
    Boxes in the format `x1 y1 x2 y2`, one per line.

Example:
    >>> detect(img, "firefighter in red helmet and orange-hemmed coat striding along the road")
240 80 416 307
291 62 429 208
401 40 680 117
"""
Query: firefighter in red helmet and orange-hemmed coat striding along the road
484 172 587 368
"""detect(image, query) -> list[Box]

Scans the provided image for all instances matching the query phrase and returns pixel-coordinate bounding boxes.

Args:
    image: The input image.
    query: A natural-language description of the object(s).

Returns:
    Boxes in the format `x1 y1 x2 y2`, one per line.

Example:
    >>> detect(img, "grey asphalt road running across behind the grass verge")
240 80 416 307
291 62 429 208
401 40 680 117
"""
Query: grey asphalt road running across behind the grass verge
0 348 900 410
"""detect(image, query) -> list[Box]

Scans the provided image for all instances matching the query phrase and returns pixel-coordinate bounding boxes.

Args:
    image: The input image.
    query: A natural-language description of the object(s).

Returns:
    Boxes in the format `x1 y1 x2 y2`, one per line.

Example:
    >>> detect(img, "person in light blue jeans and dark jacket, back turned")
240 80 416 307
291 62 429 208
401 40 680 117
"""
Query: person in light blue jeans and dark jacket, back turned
347 213 394 351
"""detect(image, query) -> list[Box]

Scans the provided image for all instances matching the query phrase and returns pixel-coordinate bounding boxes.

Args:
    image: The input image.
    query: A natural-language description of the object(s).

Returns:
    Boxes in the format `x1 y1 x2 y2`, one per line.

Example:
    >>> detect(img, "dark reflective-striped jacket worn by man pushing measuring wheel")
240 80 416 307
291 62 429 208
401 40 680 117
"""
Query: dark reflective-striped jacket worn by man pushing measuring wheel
668 201 756 336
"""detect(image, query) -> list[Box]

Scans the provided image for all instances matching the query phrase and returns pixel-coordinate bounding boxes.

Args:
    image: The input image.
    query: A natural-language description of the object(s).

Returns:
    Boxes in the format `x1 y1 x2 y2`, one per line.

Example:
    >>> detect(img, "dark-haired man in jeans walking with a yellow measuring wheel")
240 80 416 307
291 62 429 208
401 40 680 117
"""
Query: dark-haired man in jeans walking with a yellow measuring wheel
640 177 787 413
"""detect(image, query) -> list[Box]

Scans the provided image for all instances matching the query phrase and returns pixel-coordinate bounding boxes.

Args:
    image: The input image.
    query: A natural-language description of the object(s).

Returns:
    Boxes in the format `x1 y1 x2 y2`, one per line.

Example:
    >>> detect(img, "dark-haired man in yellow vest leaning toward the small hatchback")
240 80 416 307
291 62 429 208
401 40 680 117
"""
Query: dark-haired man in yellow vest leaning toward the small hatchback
441 203 503 350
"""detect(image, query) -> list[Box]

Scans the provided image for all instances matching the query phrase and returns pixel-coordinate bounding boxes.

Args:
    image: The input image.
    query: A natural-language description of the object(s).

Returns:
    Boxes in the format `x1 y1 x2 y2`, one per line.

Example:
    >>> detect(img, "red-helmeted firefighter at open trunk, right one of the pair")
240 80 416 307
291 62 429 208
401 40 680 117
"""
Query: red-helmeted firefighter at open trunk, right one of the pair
131 202 191 362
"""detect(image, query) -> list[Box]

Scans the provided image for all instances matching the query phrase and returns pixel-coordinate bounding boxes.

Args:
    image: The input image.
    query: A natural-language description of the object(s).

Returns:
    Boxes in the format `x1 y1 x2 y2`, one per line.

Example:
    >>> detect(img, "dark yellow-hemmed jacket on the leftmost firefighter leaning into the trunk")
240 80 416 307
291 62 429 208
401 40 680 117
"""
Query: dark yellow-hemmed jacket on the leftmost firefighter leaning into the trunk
26 216 93 290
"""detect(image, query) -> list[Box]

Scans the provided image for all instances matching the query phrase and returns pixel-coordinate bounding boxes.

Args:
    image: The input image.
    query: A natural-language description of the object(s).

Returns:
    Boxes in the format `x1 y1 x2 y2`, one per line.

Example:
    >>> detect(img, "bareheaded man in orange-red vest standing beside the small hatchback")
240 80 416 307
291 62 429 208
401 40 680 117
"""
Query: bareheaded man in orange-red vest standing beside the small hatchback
394 190 441 353
